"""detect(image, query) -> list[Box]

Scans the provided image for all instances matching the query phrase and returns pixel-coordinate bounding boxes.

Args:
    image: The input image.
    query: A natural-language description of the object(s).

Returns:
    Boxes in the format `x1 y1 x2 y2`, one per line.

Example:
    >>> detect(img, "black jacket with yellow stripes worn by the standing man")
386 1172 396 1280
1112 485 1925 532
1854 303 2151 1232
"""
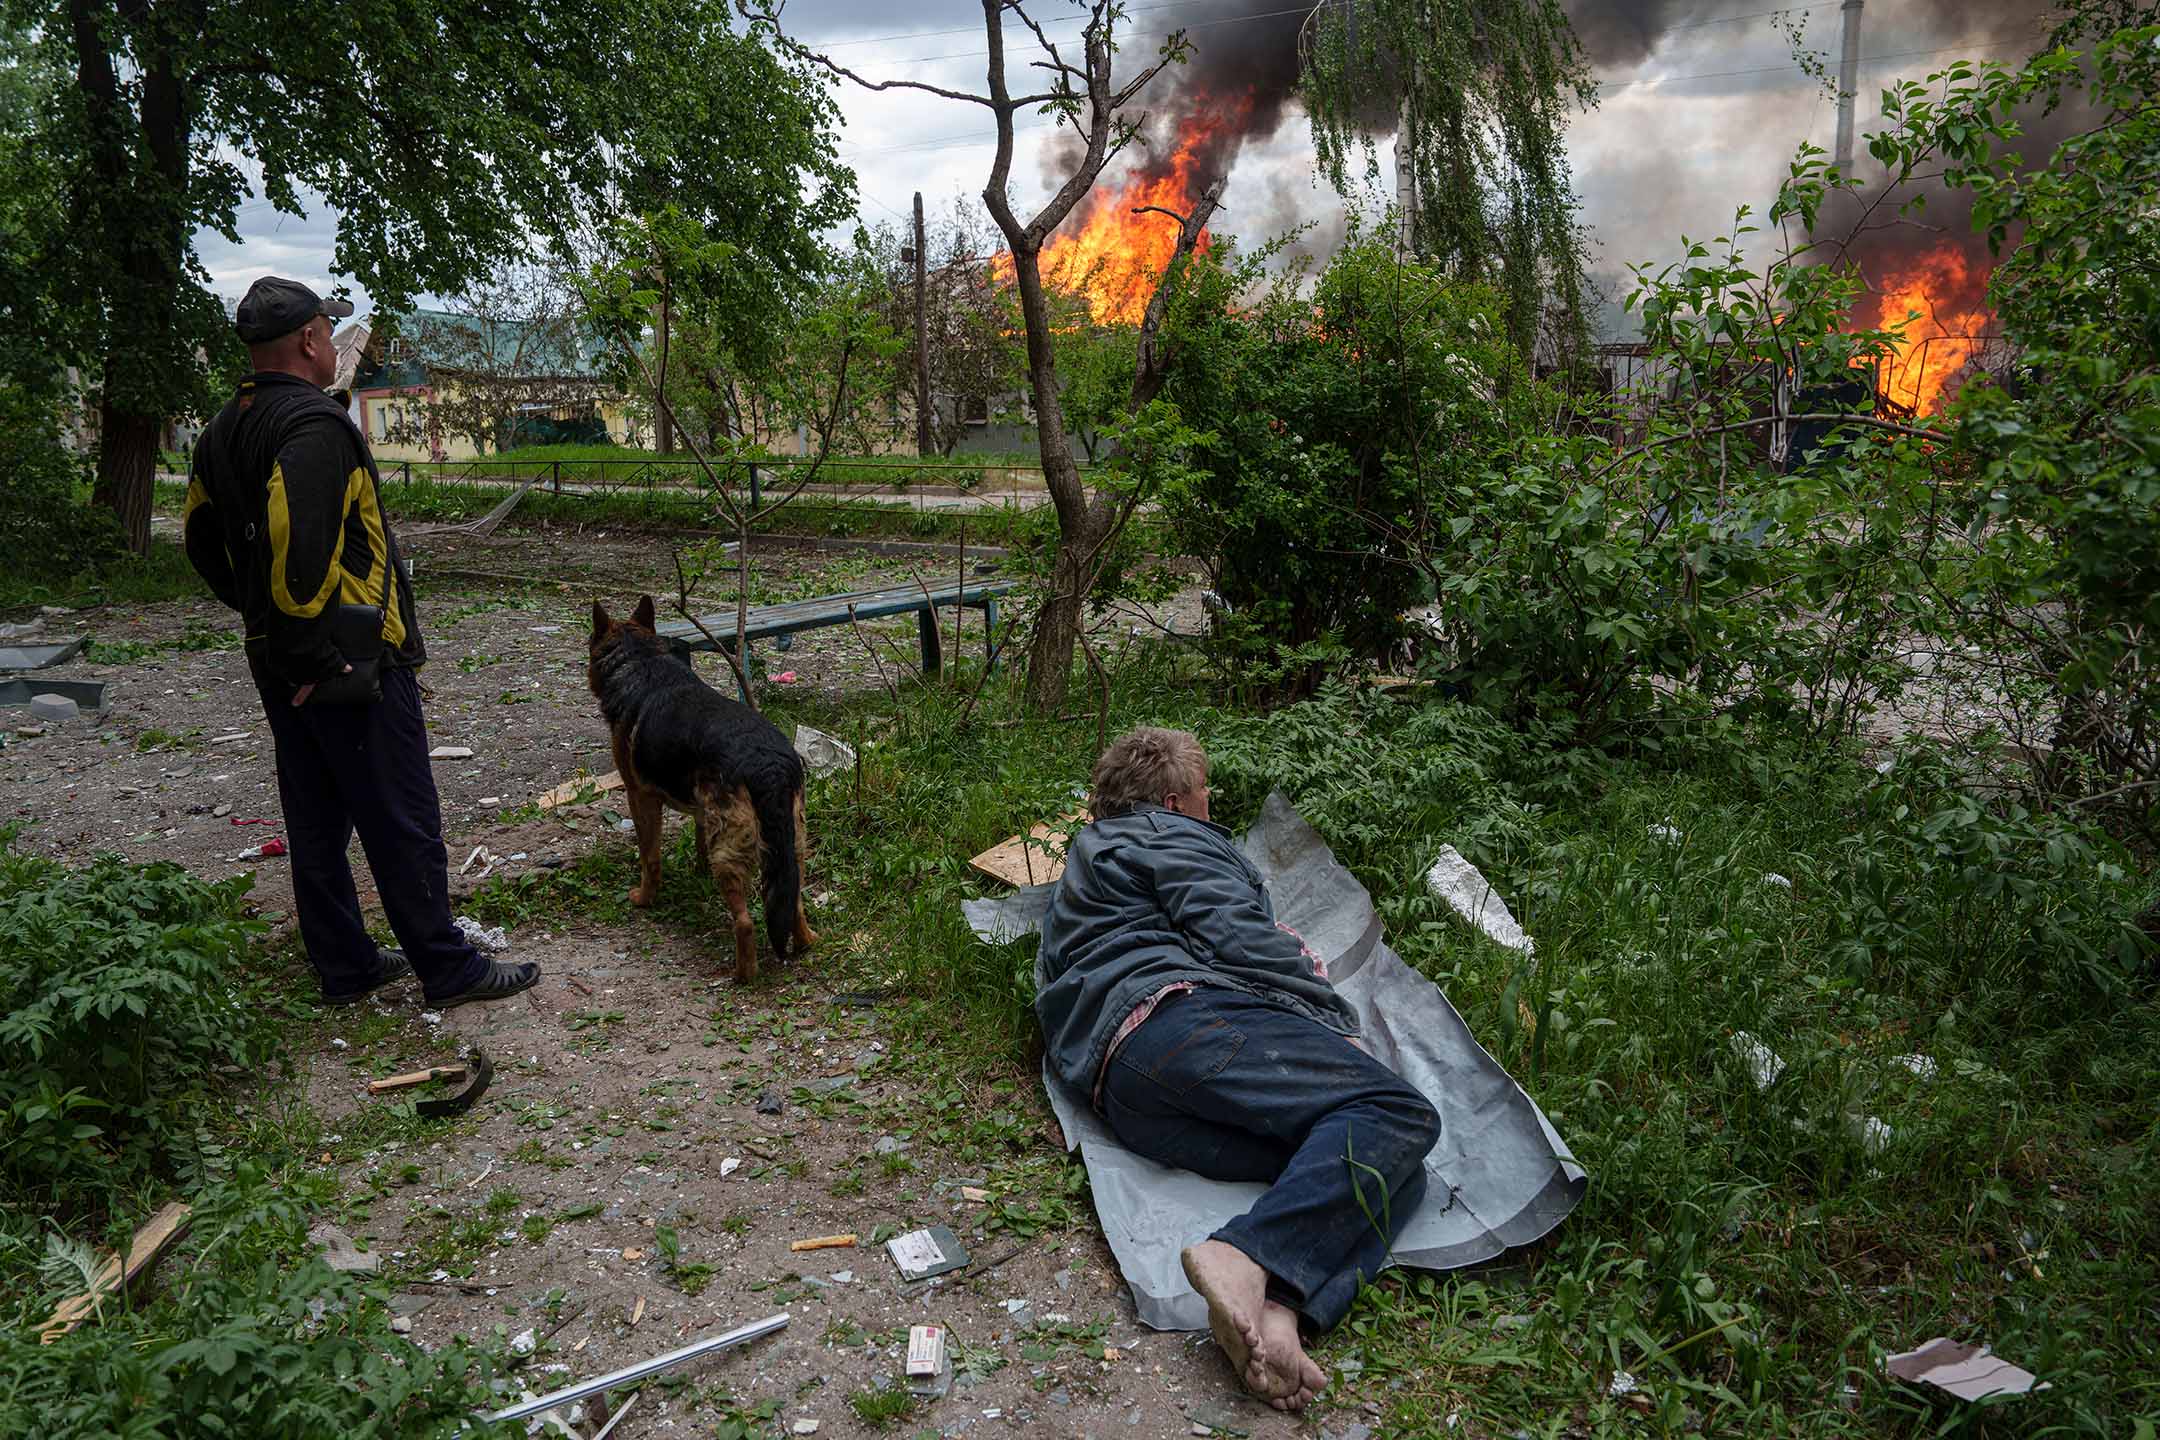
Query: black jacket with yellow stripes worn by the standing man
186 371 428 689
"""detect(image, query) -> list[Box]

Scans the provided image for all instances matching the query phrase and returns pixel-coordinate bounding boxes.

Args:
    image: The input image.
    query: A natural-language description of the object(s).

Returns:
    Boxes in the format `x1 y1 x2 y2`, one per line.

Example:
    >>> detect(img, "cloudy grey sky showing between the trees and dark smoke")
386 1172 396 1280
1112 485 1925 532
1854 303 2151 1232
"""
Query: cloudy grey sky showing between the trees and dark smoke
197 0 2046 334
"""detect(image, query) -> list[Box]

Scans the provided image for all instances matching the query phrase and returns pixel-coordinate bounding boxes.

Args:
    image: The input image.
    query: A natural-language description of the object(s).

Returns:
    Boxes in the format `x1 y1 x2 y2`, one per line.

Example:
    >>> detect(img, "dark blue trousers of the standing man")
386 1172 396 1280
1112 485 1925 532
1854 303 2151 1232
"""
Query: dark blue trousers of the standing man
261 667 488 1000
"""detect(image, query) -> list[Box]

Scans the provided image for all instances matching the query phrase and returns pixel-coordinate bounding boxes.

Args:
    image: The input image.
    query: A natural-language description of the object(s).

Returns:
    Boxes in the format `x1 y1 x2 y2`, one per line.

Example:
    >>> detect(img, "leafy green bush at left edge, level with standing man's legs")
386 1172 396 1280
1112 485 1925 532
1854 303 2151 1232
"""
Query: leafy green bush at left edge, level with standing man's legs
0 848 274 1215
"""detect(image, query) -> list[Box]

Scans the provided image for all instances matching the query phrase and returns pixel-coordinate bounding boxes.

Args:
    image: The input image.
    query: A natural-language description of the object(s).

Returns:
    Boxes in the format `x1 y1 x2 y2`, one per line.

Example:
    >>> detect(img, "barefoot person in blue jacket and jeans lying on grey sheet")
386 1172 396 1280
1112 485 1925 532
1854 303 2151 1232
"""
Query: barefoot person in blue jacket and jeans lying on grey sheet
1035 730 1441 1410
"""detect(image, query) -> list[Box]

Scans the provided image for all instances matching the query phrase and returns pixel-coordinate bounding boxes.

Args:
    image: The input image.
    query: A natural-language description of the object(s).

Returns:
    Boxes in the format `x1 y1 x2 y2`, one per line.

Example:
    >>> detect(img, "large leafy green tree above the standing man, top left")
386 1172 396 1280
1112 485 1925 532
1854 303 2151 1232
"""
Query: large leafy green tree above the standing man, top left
4 0 851 551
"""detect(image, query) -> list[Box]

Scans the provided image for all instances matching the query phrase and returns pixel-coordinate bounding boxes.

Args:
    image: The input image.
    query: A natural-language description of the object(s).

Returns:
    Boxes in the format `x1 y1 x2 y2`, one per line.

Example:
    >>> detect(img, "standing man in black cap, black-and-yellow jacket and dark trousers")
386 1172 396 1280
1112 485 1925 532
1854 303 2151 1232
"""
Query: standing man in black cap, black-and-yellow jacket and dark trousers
186 276 540 1008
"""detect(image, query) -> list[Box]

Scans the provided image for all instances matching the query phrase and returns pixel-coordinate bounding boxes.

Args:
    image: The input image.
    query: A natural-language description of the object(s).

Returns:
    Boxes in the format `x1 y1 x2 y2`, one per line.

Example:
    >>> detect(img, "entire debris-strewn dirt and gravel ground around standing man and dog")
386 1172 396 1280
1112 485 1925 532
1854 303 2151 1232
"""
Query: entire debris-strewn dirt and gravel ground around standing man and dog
0 531 1330 1440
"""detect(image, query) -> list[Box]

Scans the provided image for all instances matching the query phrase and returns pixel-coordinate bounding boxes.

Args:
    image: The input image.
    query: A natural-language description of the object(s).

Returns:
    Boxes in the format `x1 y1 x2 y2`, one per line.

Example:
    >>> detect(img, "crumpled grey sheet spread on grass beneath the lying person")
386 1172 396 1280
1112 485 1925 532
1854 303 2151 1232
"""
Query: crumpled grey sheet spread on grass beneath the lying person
961 794 1583 1330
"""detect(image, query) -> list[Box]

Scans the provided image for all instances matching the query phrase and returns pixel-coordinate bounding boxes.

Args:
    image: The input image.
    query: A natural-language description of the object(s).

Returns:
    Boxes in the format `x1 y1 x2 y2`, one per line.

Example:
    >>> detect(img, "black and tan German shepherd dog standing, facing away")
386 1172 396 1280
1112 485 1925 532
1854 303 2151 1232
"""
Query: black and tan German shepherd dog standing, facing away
585 596 816 982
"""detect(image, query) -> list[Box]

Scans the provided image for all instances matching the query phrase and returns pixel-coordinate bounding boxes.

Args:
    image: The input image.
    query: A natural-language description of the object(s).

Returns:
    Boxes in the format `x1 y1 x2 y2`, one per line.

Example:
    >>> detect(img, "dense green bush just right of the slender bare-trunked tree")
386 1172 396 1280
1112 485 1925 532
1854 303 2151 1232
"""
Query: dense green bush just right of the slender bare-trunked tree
1162 242 1536 693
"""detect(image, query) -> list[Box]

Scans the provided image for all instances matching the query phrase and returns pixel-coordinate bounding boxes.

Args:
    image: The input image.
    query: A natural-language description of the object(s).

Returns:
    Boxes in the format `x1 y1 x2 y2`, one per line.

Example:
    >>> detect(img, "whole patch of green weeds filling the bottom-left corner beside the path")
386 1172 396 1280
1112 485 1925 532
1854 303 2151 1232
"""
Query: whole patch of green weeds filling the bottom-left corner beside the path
0 848 516 1440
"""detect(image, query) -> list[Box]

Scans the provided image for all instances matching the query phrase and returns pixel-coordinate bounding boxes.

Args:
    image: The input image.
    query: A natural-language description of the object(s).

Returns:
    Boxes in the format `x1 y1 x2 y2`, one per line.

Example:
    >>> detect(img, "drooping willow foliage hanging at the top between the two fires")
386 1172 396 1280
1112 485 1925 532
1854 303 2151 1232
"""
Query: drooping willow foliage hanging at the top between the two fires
1302 0 1594 356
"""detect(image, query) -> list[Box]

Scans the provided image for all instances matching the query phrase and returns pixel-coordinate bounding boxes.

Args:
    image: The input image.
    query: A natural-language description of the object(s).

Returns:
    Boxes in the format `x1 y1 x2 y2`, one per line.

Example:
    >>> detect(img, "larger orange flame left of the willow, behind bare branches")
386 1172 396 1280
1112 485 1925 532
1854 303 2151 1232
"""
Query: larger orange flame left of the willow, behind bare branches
994 95 1253 326
